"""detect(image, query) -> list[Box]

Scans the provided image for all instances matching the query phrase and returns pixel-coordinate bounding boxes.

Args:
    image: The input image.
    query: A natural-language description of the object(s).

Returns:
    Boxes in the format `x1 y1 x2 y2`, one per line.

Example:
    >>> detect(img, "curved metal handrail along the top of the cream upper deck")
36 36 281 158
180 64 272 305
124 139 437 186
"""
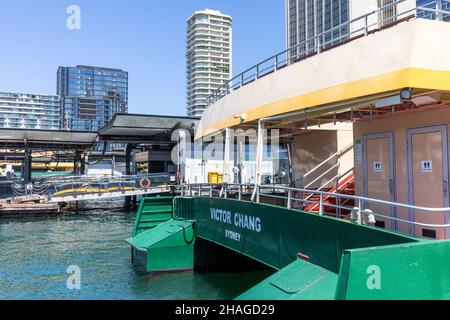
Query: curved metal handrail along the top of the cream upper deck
206 0 450 106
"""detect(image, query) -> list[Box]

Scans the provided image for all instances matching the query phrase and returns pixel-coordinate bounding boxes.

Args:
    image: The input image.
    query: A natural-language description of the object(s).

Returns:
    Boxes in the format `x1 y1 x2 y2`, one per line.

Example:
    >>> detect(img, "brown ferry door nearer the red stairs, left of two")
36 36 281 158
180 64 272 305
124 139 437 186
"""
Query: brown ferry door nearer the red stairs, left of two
364 132 397 230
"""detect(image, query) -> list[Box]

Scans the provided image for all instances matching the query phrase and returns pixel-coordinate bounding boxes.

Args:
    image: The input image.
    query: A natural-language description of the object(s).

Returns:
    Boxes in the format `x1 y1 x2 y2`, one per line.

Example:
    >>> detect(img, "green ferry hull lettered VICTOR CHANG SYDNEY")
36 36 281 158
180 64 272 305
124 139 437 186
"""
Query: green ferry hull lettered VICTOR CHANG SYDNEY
128 197 450 300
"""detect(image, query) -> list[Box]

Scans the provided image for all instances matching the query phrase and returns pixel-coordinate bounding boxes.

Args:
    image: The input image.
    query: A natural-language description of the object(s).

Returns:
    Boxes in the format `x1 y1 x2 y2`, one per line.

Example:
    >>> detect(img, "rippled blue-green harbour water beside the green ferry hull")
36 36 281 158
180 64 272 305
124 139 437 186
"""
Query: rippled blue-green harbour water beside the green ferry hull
0 201 269 300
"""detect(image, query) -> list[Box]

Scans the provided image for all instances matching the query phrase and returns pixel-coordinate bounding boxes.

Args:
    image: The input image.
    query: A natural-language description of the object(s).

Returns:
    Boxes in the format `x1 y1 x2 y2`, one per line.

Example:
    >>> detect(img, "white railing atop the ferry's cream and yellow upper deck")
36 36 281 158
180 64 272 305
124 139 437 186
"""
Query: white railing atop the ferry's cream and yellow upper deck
207 0 450 105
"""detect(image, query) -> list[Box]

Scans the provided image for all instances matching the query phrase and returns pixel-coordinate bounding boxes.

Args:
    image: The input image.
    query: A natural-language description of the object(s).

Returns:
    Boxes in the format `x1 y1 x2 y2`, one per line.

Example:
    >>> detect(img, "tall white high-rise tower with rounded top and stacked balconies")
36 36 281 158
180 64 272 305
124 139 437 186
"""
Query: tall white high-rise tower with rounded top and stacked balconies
186 9 232 117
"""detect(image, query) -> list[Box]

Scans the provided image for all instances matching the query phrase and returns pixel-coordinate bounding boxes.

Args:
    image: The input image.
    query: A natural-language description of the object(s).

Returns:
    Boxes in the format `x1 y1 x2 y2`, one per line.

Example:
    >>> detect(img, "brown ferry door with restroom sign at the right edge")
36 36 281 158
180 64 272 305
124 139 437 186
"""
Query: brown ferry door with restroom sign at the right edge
408 126 449 239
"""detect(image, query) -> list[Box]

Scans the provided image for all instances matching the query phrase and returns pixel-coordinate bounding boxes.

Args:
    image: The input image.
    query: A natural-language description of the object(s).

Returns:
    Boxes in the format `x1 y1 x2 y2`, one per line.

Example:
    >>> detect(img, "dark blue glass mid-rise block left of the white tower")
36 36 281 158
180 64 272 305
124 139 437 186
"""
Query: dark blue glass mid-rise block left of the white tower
57 66 128 131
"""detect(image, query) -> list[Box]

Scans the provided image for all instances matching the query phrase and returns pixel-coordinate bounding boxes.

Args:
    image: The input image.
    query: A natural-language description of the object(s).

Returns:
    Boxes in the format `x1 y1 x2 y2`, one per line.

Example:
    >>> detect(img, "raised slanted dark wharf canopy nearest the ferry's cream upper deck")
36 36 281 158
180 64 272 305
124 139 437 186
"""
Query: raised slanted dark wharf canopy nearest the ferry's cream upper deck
99 113 200 144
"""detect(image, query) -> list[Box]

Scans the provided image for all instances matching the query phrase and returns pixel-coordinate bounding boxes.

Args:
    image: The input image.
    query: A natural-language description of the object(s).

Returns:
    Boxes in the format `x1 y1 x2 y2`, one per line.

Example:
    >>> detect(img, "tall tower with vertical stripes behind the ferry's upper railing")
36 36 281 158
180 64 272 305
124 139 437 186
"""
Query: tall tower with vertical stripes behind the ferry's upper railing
286 0 450 58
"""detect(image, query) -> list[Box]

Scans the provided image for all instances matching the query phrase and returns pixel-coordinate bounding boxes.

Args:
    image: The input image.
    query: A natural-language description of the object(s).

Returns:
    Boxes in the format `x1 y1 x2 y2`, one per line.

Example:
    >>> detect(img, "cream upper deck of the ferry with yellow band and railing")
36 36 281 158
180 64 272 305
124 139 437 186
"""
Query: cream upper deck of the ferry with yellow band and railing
196 1 450 139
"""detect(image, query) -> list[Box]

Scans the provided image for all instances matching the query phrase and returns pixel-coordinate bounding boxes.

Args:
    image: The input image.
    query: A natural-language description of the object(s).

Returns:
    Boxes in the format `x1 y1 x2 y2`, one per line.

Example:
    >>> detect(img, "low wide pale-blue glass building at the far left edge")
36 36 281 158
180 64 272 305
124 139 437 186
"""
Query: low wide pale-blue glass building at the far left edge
0 92 60 130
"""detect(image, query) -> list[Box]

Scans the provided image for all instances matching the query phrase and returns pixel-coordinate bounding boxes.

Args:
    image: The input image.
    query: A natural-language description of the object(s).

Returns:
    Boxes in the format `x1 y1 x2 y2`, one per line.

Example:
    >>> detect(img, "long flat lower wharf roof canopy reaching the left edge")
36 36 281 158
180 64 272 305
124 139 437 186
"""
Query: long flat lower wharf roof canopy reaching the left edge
0 128 97 151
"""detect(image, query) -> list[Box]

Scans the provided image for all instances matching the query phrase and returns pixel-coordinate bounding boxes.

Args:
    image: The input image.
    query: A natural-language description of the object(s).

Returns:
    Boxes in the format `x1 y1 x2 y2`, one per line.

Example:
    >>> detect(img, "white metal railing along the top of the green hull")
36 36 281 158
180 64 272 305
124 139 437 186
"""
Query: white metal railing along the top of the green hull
181 183 450 235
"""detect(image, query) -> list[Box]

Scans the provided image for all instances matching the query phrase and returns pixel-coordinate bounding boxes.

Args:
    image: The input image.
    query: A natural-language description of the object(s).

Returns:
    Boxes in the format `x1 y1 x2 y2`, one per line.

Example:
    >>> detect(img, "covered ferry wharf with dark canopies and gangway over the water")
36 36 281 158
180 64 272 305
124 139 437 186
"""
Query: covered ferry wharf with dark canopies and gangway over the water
0 114 198 215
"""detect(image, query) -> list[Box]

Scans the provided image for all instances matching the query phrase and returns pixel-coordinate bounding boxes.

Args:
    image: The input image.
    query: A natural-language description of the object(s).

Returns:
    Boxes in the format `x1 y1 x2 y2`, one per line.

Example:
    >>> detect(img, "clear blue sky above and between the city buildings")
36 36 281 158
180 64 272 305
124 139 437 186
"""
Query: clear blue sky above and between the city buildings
0 0 285 115
